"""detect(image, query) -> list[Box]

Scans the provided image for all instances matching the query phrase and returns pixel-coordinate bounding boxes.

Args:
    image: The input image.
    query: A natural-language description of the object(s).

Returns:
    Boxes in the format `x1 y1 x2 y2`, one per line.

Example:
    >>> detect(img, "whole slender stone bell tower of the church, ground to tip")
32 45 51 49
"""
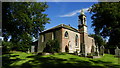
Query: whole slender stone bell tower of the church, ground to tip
78 10 88 56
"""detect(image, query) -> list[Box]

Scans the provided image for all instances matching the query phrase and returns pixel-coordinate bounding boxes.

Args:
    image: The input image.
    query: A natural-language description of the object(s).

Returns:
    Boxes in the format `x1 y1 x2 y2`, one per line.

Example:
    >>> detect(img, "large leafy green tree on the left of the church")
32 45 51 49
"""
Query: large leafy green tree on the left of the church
2 2 50 51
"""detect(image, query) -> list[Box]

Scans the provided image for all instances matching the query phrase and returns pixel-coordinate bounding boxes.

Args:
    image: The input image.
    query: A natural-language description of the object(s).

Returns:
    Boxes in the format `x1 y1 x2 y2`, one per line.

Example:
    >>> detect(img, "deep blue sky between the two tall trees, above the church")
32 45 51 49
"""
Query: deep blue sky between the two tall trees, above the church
44 2 96 34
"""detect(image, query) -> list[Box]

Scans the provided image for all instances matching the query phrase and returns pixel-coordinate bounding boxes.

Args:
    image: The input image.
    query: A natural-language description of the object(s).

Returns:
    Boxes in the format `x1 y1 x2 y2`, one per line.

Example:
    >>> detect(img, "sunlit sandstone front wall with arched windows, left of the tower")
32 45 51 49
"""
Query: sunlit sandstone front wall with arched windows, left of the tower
62 28 80 53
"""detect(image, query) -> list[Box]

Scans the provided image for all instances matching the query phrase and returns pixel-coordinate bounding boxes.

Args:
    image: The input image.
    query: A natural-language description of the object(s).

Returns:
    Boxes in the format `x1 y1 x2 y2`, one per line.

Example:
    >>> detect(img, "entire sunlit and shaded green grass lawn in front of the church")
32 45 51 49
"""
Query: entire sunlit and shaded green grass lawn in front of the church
2 51 120 68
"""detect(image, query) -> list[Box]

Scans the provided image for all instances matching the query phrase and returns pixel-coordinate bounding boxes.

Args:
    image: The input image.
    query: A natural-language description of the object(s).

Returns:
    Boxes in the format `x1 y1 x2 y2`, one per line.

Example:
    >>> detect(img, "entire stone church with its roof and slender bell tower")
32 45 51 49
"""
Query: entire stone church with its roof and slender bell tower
38 11 96 56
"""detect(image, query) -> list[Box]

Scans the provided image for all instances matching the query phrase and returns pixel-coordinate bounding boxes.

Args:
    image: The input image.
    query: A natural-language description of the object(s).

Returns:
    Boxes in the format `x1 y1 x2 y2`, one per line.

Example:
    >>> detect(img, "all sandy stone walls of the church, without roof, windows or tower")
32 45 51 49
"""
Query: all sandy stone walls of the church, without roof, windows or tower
38 28 95 53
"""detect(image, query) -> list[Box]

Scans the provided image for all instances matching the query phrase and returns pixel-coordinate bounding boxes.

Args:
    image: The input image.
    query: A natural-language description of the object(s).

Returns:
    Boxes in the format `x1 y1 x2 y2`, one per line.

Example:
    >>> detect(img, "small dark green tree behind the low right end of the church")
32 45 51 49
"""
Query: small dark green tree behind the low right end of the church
89 34 106 47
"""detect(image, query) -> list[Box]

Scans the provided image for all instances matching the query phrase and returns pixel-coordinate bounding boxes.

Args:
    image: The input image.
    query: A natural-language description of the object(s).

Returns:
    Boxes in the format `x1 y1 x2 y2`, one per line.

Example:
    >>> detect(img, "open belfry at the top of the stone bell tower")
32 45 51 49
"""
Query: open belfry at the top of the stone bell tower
78 10 87 33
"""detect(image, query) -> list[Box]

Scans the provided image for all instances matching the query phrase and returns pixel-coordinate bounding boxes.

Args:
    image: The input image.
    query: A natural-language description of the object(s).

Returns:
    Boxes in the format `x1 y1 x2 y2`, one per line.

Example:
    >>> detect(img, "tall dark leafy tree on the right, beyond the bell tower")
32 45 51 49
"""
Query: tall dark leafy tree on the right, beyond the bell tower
90 2 120 48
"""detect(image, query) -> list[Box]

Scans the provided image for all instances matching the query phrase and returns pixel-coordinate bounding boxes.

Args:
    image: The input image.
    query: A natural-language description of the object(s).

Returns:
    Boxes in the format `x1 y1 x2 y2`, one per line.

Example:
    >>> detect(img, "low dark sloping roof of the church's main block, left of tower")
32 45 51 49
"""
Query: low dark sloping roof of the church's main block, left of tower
41 24 78 33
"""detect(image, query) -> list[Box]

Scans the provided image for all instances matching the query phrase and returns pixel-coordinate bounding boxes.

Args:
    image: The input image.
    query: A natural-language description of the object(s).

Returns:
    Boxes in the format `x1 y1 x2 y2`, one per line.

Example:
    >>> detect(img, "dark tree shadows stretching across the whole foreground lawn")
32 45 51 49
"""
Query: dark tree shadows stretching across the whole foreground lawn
3 55 119 68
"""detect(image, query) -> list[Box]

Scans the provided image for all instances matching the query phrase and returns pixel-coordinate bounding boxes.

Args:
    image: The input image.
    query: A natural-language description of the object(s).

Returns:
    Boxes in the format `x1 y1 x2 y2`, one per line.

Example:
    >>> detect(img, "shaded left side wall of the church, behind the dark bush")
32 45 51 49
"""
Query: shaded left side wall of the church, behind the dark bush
38 29 62 52
